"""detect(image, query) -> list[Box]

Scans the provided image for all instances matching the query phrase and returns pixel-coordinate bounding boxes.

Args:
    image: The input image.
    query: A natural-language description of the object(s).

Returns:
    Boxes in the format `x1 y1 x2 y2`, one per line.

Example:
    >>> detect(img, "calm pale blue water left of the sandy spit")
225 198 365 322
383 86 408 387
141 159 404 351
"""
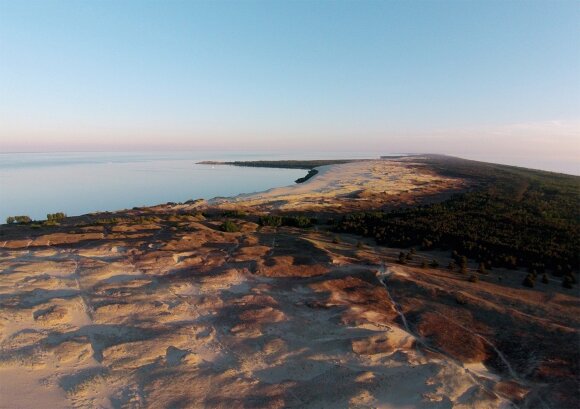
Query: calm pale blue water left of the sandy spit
0 152 378 223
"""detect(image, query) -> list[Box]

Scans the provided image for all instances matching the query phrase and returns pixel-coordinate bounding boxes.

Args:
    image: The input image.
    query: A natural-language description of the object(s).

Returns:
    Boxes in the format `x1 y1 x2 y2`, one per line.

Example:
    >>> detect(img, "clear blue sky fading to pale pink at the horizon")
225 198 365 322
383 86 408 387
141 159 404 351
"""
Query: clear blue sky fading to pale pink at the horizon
0 0 580 174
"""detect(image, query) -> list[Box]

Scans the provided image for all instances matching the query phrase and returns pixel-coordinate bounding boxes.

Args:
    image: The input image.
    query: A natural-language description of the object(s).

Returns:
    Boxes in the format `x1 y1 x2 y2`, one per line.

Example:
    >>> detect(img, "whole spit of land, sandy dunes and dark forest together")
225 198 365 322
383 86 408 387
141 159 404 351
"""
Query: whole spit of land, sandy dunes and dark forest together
0 155 580 409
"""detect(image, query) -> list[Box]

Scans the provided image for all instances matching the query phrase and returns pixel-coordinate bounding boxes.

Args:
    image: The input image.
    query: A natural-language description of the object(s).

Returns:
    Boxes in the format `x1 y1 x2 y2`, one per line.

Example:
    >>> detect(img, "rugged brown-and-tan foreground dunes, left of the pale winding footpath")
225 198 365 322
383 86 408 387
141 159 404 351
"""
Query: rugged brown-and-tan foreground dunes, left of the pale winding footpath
0 222 508 409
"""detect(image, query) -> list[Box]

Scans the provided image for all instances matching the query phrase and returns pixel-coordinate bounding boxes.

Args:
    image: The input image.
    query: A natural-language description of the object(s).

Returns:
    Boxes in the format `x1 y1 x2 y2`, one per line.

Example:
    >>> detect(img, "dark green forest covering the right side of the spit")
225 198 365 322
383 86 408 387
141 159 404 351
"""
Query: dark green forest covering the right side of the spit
334 156 580 276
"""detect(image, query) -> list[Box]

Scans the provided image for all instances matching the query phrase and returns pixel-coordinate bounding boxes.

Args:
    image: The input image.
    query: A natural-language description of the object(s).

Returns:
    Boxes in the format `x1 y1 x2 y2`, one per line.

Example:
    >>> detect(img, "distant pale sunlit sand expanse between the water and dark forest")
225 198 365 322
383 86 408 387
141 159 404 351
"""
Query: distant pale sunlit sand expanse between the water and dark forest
213 157 465 211
